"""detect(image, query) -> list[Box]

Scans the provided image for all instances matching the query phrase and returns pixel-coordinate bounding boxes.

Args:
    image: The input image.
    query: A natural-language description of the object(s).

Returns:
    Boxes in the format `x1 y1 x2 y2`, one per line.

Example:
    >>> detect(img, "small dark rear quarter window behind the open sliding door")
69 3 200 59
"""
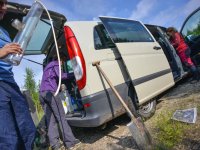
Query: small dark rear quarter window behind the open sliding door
94 24 115 50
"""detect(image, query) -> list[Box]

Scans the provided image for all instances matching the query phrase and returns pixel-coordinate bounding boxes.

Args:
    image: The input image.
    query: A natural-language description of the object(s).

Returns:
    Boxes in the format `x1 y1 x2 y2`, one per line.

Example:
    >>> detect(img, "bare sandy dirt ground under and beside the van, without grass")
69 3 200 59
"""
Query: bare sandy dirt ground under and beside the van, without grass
70 78 200 150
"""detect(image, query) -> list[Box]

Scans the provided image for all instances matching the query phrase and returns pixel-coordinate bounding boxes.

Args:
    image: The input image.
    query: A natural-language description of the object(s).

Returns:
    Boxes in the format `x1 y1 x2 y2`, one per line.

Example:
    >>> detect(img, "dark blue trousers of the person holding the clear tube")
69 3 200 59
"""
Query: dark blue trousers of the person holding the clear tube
0 81 36 150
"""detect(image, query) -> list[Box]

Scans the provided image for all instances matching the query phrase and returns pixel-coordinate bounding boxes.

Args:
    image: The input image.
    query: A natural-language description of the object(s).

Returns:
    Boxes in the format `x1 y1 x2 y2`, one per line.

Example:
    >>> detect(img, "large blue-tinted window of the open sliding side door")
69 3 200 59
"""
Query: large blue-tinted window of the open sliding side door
99 18 154 43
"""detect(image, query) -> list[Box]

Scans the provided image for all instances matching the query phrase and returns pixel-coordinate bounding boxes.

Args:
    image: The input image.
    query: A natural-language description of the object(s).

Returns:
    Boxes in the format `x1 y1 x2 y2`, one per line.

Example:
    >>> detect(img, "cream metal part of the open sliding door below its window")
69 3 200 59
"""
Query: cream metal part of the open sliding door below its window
116 43 174 103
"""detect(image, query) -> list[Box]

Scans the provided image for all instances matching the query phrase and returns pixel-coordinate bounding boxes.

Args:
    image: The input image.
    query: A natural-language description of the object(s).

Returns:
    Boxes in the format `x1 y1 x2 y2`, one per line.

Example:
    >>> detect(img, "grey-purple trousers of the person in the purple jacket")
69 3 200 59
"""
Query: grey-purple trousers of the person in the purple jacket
40 92 76 148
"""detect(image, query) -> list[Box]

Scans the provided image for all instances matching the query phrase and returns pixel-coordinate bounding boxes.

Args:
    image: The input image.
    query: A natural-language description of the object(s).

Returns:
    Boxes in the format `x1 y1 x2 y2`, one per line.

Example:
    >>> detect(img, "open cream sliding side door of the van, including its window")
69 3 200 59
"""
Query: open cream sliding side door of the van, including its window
100 17 174 104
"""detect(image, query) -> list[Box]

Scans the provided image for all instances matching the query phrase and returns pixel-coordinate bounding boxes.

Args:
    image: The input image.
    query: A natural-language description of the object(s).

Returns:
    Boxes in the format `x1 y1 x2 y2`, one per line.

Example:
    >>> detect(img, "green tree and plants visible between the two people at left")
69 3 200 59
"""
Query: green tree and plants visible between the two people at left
24 68 44 120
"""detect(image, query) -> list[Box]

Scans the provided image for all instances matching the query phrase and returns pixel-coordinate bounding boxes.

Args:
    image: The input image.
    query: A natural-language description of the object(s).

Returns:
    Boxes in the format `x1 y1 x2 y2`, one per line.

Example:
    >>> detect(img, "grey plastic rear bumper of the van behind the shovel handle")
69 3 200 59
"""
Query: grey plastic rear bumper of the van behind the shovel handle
67 83 128 127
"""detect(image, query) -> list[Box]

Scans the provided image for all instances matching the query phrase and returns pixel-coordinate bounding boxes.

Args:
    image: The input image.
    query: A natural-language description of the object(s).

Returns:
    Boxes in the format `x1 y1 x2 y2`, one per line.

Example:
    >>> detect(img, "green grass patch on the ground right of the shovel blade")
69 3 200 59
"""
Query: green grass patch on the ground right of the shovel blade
155 112 189 150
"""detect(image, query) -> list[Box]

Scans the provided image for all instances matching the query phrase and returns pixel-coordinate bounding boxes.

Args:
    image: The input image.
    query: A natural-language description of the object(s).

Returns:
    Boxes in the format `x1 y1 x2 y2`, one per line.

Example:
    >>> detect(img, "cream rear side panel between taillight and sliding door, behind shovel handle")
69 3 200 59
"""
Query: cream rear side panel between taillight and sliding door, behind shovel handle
65 21 127 97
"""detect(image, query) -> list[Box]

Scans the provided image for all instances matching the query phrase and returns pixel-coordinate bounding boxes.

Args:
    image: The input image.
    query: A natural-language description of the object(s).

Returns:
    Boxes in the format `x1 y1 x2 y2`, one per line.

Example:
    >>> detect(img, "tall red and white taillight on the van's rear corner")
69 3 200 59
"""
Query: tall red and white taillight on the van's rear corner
64 26 86 90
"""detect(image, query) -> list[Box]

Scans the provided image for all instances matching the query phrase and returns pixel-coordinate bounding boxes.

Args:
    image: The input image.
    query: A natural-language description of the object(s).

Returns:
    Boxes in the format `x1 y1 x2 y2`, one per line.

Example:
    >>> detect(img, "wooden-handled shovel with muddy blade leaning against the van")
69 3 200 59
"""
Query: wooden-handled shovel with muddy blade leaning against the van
92 61 151 150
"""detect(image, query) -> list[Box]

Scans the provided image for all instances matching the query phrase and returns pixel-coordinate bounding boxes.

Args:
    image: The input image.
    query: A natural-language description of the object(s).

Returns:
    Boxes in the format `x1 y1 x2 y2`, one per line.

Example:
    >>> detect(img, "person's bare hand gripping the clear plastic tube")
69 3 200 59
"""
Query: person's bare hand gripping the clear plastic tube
0 43 22 58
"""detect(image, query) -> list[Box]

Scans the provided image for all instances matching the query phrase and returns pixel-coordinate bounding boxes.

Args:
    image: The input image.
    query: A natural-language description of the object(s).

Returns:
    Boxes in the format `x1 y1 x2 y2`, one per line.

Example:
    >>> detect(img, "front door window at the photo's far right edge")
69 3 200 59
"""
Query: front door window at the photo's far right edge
181 10 200 41
